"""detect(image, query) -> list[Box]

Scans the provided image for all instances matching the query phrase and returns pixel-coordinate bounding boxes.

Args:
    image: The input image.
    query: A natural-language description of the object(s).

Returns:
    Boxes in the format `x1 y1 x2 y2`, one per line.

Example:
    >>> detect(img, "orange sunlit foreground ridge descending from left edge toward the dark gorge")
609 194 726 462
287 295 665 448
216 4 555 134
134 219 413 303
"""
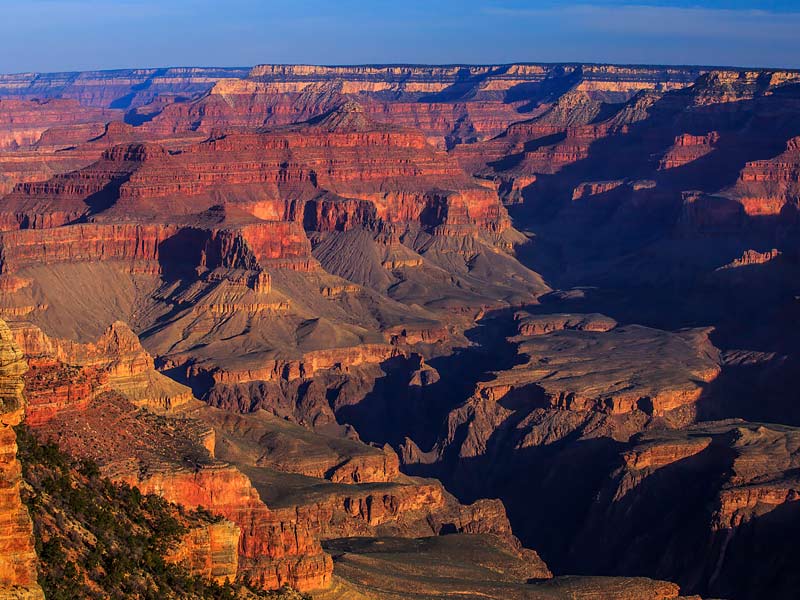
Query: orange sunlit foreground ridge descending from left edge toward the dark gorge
14 324 564 589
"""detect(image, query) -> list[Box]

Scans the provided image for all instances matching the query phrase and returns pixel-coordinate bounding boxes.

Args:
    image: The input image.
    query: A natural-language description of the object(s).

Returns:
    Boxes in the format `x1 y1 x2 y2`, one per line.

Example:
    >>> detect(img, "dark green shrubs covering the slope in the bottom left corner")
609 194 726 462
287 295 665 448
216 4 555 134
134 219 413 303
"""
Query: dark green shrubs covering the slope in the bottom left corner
17 426 308 600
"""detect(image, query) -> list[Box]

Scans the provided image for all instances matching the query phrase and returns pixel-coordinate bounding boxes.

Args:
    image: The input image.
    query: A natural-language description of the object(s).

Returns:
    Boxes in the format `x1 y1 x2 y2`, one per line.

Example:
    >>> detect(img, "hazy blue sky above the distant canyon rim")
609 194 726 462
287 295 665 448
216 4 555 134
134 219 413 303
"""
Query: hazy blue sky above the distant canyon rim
0 0 800 73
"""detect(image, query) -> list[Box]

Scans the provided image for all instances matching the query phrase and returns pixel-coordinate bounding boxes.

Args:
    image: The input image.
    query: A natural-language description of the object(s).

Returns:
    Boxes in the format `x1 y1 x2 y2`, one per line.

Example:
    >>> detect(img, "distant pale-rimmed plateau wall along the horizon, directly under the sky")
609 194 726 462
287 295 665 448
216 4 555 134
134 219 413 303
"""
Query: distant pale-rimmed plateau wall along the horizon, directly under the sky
141 64 702 146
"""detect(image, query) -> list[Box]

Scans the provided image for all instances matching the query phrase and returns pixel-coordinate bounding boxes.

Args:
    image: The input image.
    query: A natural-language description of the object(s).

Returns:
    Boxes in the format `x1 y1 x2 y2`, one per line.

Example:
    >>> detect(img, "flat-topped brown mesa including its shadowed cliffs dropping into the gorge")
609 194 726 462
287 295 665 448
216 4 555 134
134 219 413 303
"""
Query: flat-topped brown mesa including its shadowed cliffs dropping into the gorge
400 313 721 592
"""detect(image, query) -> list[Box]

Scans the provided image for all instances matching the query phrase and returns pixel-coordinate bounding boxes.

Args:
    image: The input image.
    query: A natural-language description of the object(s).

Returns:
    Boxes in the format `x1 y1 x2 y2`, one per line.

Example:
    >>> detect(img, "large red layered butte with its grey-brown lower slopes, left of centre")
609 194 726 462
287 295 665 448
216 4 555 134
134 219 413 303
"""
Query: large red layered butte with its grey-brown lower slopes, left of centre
0 103 549 424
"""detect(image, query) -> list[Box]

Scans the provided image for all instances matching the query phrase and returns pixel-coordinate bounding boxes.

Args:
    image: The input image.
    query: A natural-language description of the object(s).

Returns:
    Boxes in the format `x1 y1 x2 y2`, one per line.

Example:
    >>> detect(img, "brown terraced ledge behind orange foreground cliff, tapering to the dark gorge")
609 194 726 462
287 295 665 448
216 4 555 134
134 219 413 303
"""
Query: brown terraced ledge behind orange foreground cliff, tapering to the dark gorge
194 400 536 550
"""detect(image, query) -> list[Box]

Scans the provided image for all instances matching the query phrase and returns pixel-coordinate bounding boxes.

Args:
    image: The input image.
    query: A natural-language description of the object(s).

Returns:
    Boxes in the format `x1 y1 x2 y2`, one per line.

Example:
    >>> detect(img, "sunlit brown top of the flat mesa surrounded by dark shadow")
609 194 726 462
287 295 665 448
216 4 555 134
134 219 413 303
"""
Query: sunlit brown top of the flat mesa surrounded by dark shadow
438 324 720 446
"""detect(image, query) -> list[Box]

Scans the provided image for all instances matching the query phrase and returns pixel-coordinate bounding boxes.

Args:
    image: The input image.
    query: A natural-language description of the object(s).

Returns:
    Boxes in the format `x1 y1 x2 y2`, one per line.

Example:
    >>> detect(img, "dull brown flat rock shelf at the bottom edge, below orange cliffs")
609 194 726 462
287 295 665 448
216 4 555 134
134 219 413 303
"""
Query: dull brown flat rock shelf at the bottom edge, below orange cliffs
315 535 700 600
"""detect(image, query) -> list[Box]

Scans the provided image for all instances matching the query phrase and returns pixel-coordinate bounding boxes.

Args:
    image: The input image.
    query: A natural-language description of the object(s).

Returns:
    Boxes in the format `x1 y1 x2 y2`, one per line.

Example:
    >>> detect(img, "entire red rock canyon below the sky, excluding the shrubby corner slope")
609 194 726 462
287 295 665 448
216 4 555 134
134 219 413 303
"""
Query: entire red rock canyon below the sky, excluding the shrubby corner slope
0 63 800 600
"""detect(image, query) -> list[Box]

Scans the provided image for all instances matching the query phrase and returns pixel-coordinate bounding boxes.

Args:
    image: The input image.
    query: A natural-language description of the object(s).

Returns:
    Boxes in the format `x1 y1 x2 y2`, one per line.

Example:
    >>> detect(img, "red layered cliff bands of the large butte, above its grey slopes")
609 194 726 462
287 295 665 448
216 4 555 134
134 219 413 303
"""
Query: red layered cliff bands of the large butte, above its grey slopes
0 96 546 360
